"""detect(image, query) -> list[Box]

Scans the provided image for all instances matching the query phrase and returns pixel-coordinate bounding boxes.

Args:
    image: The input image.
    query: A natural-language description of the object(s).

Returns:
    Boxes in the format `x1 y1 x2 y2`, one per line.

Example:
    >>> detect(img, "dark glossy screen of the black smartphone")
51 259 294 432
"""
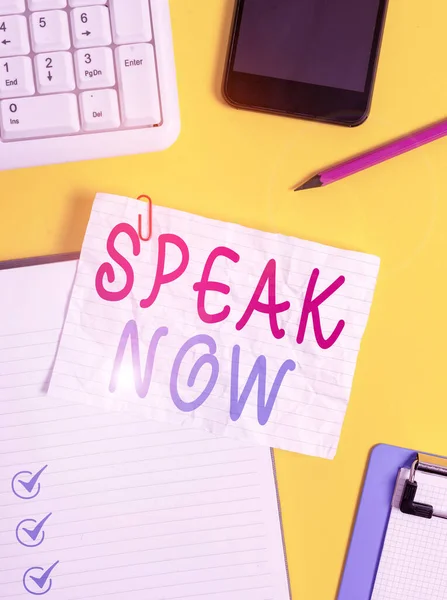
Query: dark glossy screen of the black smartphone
233 0 380 92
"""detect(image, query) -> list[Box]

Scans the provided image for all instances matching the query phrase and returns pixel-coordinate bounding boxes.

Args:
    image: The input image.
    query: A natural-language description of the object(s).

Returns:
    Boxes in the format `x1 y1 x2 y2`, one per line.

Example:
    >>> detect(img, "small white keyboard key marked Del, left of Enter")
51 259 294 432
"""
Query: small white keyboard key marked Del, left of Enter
80 90 120 131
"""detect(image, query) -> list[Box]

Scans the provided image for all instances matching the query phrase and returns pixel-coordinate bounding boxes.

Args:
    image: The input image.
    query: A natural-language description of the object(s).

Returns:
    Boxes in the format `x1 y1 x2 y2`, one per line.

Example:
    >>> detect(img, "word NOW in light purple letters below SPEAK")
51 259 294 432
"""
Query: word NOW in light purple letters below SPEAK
109 320 296 425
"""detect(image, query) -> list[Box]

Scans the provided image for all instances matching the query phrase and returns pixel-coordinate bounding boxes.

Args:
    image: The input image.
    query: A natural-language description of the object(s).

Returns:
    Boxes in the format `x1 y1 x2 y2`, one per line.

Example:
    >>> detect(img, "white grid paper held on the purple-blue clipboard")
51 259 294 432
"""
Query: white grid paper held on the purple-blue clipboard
371 469 447 600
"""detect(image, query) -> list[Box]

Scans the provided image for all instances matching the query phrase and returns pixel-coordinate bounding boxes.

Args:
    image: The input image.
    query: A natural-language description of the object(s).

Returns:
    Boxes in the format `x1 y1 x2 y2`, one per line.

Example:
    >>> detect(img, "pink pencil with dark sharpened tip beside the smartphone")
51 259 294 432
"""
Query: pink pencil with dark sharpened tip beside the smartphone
295 119 447 192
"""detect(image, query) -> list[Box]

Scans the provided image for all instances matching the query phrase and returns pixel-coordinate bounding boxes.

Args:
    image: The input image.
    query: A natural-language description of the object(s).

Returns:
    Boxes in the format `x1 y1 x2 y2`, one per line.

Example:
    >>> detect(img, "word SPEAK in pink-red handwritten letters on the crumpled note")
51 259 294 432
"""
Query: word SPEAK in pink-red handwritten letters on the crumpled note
95 223 345 349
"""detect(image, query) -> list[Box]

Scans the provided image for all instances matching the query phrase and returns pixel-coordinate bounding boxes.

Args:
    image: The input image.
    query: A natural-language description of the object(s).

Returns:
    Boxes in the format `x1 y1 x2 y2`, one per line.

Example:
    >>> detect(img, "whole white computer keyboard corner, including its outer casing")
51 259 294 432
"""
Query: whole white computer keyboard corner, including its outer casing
0 0 180 170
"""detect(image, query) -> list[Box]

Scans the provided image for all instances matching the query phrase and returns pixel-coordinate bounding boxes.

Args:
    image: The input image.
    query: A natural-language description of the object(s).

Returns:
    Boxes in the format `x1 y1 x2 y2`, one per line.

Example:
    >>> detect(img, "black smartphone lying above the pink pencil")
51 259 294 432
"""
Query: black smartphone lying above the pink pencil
224 0 387 127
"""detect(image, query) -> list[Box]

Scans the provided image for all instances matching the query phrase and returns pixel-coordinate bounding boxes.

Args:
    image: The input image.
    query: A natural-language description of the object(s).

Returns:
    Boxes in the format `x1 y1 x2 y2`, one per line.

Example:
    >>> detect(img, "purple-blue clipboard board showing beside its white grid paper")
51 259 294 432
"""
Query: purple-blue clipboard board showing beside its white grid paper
337 444 447 600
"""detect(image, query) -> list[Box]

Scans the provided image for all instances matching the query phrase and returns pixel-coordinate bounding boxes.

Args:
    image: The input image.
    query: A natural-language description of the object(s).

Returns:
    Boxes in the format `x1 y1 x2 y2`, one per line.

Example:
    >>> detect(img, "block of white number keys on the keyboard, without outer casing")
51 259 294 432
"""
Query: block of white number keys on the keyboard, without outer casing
0 0 162 142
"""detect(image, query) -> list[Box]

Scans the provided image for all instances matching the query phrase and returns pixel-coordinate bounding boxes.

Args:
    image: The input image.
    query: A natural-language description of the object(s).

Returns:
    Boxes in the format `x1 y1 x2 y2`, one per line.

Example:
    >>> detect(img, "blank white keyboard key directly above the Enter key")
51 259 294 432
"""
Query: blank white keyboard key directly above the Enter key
110 0 152 44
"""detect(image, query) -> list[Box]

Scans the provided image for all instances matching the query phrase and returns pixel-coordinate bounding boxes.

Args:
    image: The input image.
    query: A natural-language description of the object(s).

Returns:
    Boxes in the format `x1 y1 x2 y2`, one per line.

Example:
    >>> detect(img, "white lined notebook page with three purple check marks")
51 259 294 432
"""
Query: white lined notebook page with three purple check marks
0 262 290 600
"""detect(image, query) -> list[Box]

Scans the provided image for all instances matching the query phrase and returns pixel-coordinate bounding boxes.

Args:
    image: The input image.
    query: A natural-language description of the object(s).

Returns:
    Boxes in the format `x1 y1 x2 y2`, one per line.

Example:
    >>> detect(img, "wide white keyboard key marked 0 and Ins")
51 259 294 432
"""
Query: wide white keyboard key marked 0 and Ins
0 94 80 140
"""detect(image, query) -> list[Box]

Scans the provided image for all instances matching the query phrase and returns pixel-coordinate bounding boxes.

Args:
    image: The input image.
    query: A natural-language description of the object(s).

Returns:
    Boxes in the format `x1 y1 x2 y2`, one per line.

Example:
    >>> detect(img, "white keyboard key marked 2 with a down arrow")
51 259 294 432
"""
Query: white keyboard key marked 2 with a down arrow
34 52 76 94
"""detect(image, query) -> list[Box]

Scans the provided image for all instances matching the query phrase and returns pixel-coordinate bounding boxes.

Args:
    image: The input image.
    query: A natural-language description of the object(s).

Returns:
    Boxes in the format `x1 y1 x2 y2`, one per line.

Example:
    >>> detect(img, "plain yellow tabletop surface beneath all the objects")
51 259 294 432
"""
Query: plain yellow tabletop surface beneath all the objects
0 0 447 600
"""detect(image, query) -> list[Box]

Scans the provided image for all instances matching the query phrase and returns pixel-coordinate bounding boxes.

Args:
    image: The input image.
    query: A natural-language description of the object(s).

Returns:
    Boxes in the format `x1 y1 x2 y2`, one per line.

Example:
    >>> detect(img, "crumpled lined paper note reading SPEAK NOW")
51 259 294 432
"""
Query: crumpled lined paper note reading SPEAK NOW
50 194 379 458
